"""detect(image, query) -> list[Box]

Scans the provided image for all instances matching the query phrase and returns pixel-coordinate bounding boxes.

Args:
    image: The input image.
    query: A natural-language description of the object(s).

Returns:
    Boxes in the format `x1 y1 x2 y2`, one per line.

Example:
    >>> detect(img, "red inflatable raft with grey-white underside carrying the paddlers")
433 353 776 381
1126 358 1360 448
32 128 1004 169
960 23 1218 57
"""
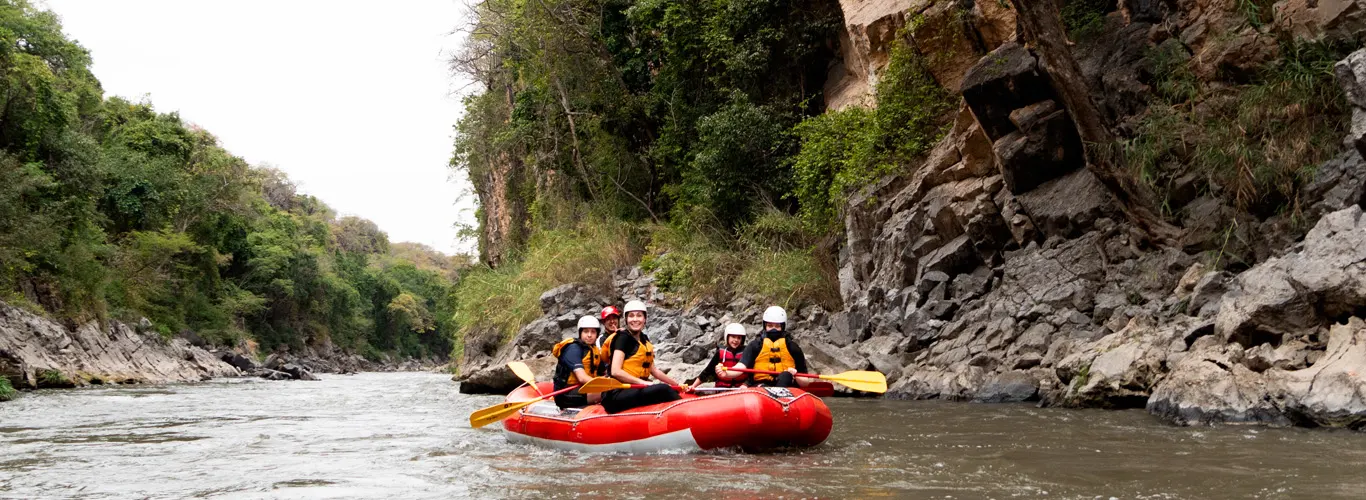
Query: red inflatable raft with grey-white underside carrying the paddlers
503 383 833 454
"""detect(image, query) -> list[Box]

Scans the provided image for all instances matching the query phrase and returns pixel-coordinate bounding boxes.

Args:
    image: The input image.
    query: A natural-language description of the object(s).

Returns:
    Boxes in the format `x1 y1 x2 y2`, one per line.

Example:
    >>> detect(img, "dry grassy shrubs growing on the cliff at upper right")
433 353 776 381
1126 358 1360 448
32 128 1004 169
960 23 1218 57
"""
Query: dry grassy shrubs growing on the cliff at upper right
1124 42 1348 217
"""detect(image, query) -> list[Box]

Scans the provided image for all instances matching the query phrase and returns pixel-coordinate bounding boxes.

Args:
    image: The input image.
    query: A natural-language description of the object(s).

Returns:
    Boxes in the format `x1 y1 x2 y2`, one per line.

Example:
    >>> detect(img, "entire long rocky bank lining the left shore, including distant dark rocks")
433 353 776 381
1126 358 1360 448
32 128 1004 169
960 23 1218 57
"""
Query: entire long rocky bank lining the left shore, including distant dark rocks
0 302 440 389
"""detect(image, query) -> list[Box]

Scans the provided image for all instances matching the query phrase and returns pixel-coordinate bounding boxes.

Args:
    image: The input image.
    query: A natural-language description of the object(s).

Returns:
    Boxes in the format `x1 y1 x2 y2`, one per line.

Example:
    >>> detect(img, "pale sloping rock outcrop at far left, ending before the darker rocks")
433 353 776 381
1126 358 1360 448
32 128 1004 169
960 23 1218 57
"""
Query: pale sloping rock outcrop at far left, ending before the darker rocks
0 303 239 388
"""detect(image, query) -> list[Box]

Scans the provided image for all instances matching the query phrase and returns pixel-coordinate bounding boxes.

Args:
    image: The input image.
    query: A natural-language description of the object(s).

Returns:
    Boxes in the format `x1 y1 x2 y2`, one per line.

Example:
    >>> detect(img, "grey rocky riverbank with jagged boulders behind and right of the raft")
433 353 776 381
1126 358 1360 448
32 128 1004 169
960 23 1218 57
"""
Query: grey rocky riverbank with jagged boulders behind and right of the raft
456 45 1366 429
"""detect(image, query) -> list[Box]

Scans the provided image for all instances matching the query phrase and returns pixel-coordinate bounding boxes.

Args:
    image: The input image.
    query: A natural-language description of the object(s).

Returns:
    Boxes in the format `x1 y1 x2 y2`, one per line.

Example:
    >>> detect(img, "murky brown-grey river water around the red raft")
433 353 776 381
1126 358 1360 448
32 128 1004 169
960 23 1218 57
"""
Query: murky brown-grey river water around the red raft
0 373 1366 500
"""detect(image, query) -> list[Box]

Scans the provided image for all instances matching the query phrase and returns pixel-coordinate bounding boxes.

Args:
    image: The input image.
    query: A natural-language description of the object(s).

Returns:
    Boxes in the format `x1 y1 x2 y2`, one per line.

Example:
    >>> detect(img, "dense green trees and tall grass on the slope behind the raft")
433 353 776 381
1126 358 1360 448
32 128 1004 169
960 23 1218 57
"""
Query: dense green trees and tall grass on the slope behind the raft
451 0 953 348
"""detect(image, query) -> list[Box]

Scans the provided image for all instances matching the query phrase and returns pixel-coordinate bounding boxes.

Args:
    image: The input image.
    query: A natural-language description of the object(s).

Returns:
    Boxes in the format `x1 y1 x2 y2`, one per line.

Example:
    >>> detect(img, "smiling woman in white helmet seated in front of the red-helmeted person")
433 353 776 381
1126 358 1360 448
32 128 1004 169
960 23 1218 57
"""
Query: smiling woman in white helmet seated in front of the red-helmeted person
602 301 680 413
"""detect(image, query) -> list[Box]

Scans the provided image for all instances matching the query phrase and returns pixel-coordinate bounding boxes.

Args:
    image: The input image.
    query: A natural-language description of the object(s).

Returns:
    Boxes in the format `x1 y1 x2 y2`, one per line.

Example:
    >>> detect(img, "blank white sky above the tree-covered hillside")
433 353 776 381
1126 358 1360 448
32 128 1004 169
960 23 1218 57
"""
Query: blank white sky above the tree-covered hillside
36 0 474 253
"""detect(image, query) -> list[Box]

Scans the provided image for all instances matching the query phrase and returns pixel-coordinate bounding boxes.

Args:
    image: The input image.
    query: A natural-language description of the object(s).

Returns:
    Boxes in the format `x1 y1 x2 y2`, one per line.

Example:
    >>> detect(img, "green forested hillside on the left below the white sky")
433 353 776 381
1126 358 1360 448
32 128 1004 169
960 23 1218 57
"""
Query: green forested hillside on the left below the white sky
0 0 462 357
